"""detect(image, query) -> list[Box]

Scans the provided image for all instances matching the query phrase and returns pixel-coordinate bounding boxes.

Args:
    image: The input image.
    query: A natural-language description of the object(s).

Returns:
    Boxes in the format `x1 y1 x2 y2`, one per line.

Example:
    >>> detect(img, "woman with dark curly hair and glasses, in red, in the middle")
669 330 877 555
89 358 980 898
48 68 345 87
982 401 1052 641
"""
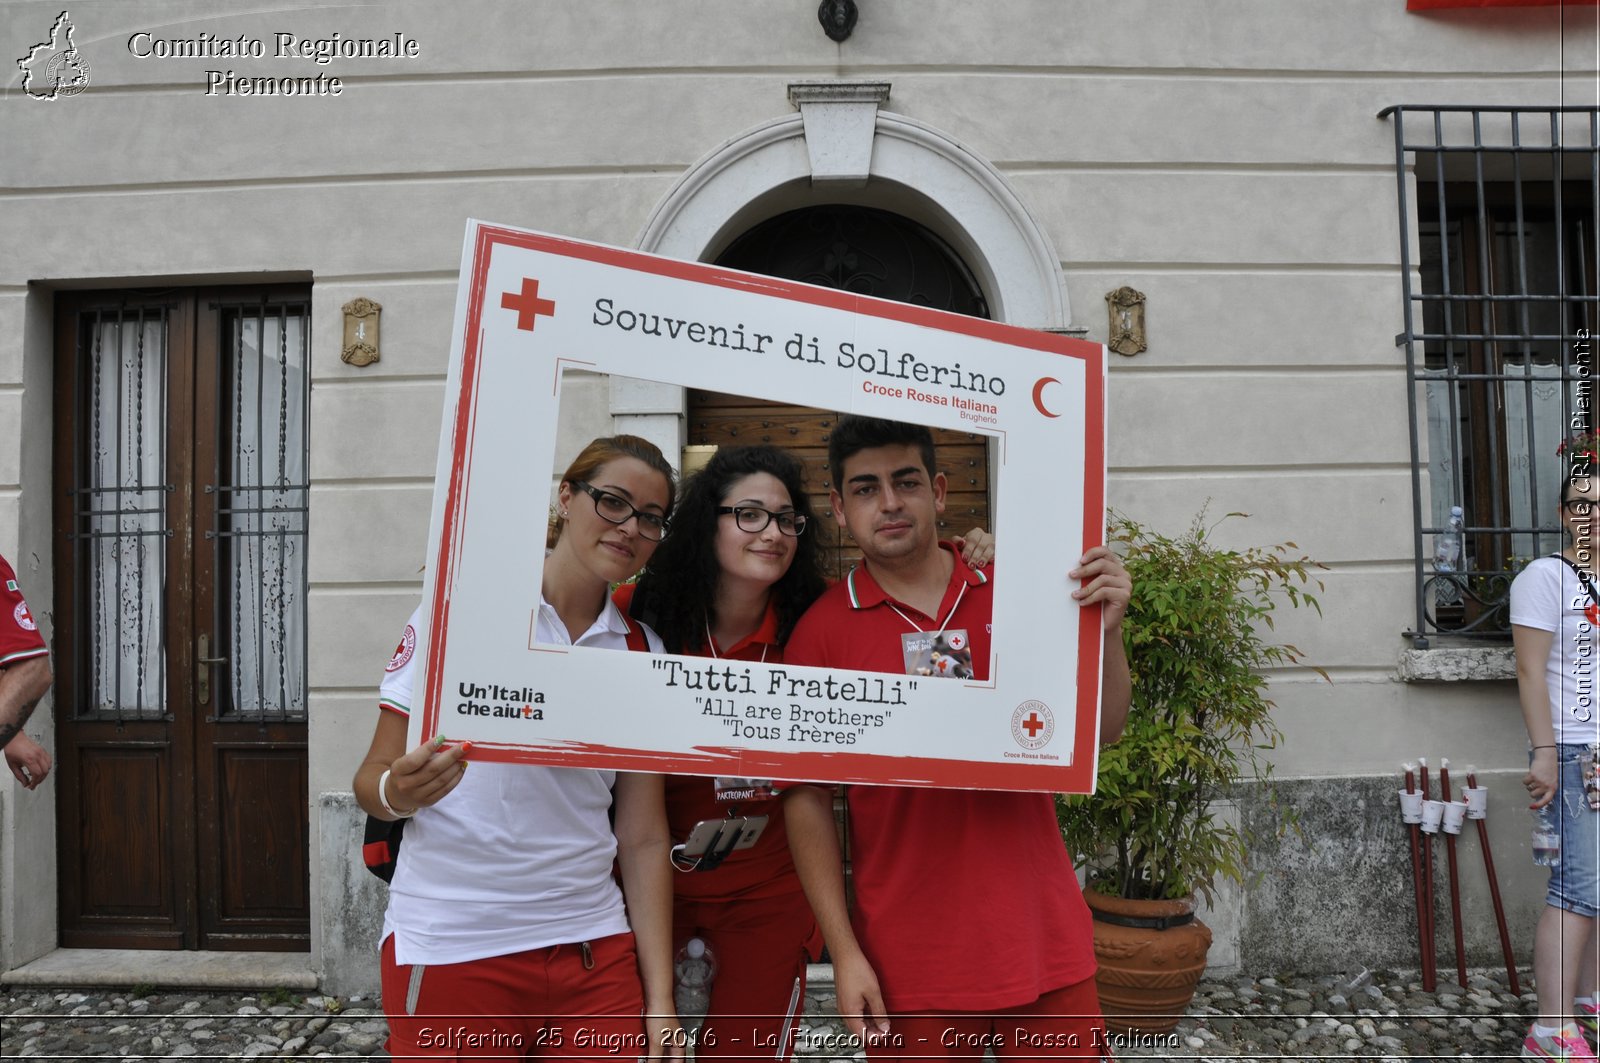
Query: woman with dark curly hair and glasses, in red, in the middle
614 447 994 1060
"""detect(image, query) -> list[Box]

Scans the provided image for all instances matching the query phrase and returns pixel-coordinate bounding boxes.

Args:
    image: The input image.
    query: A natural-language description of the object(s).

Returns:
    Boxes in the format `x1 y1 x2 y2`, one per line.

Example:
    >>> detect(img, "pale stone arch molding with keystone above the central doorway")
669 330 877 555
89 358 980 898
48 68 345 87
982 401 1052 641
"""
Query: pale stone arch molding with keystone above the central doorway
638 108 1072 330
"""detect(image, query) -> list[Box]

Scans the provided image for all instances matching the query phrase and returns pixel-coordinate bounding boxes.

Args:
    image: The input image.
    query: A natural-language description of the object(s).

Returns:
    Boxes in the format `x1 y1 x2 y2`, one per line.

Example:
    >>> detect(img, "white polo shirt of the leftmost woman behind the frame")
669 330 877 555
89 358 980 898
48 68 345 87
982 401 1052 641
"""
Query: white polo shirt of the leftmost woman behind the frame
379 597 661 964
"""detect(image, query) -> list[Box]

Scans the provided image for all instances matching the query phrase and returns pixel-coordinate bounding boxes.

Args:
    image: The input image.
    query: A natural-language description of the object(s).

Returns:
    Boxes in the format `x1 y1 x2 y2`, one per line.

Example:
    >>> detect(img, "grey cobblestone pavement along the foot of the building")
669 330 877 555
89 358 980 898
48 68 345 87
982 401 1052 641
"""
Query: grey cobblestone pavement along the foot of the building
0 970 1533 1063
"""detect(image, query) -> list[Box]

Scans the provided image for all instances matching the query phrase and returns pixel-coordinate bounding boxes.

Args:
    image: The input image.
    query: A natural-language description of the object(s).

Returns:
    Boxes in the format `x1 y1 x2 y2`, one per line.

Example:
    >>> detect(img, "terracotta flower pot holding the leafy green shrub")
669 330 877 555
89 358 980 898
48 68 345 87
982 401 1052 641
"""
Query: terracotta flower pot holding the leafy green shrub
1083 890 1211 1034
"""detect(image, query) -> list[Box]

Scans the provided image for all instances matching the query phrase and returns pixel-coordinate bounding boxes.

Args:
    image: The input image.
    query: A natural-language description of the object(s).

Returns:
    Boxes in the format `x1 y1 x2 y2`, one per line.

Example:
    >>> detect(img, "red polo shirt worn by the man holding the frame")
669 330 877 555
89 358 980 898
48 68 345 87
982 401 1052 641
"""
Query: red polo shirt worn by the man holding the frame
786 543 1094 1012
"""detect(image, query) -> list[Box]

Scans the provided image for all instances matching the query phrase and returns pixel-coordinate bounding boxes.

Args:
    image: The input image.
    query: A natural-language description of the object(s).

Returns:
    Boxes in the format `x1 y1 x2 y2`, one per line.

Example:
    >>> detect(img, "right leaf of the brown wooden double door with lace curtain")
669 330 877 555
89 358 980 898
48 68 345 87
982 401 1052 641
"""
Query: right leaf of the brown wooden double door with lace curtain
192 290 310 951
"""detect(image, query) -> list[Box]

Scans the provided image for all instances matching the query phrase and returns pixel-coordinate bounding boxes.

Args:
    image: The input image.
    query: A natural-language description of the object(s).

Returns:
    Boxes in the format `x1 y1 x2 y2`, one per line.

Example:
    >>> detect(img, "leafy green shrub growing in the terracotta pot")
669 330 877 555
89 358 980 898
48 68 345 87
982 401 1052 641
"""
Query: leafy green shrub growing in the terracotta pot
1058 511 1328 900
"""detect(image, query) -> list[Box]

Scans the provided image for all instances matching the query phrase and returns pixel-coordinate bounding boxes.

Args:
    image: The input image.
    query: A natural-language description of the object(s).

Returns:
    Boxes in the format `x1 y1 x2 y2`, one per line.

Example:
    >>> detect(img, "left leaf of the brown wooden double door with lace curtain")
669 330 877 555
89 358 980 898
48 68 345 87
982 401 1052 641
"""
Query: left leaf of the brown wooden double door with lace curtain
53 293 194 948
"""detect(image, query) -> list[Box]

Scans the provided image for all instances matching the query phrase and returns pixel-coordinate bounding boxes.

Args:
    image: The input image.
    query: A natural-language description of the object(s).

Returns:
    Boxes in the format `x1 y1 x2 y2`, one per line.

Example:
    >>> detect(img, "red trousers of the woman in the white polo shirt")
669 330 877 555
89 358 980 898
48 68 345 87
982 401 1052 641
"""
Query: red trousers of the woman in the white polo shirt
382 933 648 1063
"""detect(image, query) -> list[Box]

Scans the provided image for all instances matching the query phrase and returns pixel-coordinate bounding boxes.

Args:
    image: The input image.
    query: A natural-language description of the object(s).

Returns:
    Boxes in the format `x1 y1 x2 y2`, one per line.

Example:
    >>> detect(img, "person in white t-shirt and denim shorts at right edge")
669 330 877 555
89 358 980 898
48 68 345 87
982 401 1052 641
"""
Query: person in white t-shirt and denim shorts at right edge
1510 461 1600 1060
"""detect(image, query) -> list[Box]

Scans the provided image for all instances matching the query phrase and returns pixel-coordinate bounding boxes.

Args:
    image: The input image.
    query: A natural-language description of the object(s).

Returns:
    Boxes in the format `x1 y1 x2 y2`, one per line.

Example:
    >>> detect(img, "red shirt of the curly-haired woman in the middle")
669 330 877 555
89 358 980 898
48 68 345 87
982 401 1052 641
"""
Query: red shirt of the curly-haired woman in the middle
611 583 802 901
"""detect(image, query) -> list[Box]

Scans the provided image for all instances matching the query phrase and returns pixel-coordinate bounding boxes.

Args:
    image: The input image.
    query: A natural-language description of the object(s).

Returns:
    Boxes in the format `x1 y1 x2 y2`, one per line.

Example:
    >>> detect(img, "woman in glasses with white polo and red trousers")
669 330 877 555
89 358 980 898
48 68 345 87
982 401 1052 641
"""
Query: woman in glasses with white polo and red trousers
354 435 680 1061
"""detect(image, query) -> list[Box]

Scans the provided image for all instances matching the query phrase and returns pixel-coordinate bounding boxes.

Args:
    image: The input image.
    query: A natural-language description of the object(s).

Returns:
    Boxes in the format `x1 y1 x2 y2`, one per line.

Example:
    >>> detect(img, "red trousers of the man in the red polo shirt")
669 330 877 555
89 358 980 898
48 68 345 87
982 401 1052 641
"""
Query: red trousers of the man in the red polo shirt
867 978 1112 1061
